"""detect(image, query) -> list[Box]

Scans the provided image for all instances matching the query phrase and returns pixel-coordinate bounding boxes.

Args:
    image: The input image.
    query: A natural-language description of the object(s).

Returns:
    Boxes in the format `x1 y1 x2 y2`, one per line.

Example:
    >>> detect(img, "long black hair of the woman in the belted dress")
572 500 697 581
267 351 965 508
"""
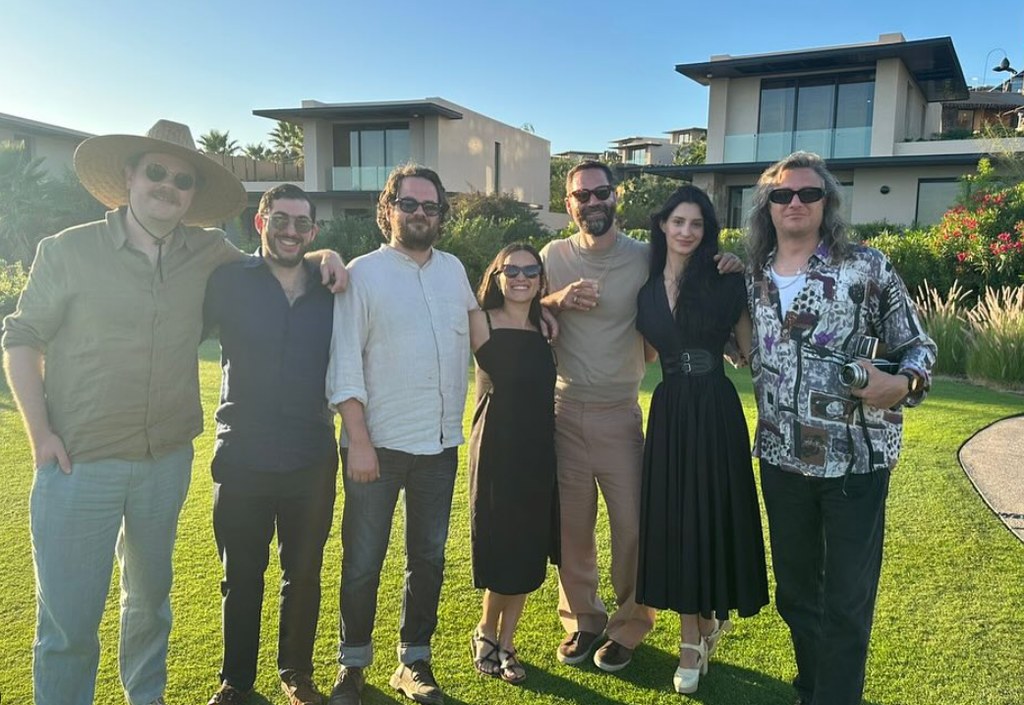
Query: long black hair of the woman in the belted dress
648 183 721 332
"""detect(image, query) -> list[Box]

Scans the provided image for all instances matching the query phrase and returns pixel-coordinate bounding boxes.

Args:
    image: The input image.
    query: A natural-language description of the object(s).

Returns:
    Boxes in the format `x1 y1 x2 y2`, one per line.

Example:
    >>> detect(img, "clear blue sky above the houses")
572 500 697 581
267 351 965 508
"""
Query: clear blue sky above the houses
0 0 1024 152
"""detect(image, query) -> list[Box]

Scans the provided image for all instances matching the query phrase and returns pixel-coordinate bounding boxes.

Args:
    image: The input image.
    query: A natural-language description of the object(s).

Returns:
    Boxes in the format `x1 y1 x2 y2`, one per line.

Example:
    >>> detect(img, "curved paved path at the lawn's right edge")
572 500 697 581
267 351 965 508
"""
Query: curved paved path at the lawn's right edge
959 414 1024 541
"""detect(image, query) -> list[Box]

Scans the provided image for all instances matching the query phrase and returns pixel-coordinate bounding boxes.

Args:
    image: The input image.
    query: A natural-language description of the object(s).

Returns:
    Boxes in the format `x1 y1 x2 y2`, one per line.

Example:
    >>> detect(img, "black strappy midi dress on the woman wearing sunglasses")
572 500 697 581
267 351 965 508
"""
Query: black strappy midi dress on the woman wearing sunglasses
469 317 559 594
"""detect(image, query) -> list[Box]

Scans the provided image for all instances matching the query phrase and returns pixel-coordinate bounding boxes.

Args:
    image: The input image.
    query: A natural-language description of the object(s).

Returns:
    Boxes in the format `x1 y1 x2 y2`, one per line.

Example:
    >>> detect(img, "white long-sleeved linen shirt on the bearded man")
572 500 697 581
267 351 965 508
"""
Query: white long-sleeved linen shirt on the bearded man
327 245 477 455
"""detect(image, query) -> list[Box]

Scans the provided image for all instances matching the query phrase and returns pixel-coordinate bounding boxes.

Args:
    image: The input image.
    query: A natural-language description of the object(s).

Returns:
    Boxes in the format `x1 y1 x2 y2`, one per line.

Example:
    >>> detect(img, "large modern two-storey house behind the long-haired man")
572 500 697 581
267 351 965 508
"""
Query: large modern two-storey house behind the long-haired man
626 34 1024 227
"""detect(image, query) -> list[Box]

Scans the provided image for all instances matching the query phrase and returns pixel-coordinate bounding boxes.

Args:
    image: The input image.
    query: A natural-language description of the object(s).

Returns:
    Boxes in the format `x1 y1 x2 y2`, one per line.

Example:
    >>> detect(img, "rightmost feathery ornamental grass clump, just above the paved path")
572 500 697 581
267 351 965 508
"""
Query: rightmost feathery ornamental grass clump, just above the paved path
967 286 1024 388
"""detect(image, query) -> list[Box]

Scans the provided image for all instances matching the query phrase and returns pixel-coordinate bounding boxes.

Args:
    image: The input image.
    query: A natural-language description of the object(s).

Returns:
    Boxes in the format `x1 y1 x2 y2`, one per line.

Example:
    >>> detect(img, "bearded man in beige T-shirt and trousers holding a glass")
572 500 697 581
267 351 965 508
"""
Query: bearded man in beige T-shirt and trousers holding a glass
541 161 742 672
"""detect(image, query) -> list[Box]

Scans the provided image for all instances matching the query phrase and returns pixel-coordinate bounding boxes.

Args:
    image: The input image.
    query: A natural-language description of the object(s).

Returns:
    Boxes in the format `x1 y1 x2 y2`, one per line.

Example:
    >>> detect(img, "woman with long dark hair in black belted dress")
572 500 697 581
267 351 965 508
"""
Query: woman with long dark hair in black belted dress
637 185 768 693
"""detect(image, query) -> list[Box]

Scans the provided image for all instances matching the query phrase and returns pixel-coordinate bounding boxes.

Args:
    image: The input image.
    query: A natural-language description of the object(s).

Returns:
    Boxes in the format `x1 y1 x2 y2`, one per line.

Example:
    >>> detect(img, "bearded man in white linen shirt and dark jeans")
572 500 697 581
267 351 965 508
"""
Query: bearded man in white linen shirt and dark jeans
327 165 477 705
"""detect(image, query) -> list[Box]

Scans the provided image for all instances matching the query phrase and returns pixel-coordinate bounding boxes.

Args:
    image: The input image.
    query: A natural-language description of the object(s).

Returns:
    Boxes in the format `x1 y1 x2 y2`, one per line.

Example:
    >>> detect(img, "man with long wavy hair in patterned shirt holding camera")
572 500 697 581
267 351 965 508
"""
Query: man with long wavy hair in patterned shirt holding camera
748 152 936 705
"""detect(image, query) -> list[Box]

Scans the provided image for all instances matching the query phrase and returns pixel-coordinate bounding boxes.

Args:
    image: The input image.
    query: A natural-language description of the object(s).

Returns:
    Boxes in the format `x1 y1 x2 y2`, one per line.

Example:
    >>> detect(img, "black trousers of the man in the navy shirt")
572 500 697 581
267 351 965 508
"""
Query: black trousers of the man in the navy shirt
213 456 338 690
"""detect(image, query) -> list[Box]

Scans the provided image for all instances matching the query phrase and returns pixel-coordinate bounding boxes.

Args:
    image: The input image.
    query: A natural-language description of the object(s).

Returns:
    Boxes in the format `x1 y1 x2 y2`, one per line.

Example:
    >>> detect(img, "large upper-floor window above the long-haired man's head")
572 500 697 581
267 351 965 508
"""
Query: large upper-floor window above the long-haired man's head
757 74 874 161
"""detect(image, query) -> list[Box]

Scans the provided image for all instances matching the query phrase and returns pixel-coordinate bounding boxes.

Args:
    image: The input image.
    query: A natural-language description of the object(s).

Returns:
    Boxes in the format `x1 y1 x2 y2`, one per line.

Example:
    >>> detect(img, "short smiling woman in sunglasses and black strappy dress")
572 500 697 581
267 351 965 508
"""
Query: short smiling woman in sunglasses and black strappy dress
469 243 558 683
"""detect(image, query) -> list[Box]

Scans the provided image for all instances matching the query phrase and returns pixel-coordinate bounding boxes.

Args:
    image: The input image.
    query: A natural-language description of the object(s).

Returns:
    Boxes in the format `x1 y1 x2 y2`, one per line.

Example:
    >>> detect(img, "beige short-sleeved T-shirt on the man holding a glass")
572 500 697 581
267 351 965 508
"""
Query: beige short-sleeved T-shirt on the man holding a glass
541 233 650 403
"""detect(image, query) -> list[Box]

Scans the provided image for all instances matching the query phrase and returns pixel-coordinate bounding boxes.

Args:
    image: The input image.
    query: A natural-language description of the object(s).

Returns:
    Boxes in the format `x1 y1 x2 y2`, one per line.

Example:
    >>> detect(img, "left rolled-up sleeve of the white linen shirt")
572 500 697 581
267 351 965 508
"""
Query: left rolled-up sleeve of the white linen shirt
327 277 370 411
